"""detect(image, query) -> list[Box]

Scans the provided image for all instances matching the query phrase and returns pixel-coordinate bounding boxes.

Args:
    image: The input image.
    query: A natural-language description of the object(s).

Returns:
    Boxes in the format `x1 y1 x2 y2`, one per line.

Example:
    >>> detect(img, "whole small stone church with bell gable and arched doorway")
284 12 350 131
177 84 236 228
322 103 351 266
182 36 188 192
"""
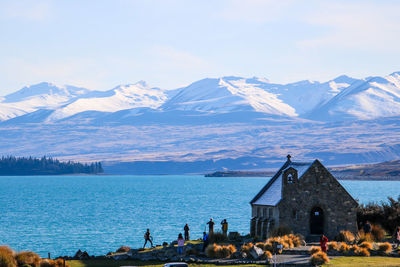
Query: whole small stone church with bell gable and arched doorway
250 155 358 239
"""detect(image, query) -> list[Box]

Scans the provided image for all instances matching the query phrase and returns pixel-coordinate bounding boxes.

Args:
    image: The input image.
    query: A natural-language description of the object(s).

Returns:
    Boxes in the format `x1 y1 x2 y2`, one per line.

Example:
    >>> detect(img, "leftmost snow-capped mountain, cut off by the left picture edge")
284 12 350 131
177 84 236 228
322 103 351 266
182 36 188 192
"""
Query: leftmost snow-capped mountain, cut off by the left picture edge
0 82 89 120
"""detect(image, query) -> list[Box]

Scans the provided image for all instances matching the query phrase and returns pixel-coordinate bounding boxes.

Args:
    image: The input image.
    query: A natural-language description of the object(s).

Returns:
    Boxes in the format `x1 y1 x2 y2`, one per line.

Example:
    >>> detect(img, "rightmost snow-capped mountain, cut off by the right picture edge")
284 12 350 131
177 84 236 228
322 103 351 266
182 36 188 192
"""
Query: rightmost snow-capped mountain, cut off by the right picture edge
307 72 400 121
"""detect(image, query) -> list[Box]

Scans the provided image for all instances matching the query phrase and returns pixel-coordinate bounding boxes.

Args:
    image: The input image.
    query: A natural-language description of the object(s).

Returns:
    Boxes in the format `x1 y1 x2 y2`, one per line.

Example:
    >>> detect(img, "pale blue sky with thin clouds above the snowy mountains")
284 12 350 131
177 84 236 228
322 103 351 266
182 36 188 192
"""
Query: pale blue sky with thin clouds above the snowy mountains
0 0 400 95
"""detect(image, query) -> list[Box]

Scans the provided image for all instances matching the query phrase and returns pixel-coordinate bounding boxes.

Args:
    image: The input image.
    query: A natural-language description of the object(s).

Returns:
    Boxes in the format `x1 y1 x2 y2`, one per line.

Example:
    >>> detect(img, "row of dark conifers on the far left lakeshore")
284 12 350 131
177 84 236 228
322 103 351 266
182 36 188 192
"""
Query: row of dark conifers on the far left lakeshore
0 156 104 175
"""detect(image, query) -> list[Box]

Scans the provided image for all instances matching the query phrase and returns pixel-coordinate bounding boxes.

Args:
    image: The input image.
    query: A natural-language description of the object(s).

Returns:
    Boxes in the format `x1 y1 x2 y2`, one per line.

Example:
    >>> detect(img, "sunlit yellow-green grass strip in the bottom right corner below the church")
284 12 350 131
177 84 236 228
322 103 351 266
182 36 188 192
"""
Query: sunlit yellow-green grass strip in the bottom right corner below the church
323 257 400 267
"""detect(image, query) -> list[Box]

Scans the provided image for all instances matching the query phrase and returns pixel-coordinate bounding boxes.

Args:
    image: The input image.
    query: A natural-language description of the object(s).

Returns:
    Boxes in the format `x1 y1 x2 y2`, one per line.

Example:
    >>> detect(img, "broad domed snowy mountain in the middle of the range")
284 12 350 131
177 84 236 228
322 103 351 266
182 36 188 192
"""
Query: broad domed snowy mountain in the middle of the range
161 77 297 116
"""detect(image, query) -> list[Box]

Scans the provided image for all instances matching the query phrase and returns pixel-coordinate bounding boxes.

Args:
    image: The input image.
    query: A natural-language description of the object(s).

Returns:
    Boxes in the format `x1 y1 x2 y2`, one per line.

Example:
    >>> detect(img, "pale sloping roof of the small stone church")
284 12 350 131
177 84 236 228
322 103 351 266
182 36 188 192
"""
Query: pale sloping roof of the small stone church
250 157 315 206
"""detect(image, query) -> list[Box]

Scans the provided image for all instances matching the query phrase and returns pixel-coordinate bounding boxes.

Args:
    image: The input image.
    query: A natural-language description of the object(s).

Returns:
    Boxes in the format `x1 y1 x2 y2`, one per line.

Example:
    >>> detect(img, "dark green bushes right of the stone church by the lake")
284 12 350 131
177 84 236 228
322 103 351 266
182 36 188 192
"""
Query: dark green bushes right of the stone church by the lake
357 196 400 236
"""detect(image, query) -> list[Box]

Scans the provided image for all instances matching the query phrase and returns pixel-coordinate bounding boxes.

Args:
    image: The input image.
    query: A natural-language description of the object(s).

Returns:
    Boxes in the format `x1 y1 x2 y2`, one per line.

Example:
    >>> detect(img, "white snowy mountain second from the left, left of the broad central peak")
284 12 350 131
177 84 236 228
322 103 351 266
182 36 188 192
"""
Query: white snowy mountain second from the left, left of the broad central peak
47 81 167 121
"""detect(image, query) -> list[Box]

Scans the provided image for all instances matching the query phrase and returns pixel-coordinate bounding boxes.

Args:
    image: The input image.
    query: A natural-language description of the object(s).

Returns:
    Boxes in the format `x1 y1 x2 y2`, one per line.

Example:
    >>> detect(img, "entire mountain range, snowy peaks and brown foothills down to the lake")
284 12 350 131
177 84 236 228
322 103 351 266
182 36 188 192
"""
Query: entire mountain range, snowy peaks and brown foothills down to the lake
0 72 400 173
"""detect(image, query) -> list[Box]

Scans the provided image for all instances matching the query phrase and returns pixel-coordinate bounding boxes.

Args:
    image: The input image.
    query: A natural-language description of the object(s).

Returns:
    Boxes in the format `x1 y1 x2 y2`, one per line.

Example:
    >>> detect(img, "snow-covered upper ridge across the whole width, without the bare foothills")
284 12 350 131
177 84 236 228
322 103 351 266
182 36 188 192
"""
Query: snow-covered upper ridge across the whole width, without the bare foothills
0 72 400 122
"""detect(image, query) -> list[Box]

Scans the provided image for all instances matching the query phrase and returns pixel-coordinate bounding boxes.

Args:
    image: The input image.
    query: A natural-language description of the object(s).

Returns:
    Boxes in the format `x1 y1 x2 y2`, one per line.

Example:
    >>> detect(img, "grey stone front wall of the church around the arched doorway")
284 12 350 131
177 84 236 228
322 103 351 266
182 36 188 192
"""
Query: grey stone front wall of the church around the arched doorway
278 161 357 239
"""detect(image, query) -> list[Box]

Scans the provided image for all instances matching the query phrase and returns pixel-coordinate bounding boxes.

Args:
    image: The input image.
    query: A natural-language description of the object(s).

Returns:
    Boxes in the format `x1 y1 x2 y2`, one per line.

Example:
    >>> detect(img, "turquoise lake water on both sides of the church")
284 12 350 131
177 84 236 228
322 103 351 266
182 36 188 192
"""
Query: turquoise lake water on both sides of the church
0 176 400 257
